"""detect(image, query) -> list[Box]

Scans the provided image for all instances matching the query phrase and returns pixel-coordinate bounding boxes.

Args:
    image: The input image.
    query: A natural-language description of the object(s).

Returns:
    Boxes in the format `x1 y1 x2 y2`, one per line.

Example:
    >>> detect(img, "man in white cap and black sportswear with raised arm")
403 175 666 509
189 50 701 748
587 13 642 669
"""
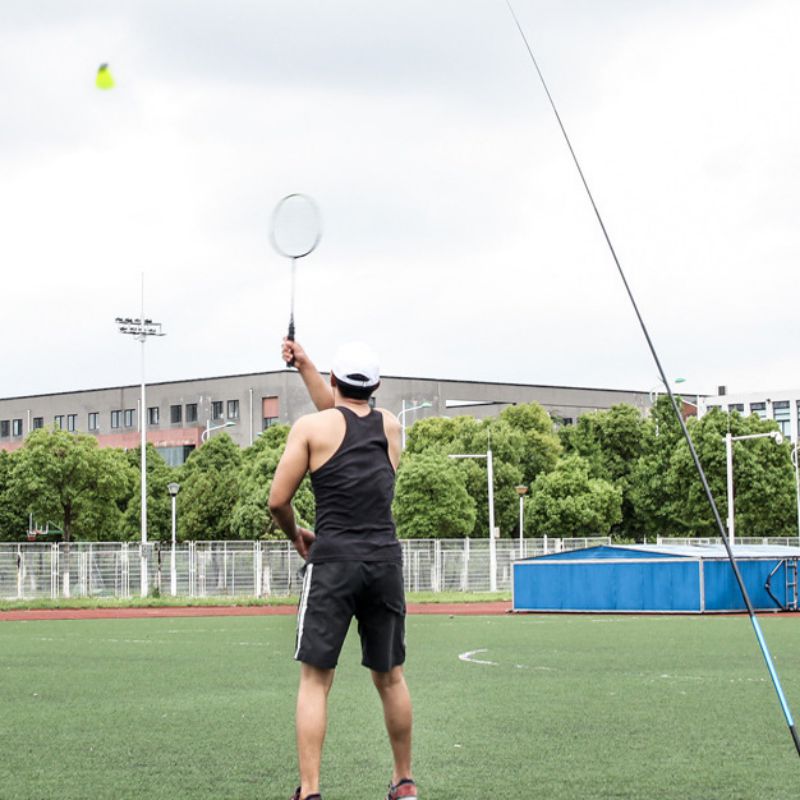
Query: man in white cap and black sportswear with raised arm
269 340 417 800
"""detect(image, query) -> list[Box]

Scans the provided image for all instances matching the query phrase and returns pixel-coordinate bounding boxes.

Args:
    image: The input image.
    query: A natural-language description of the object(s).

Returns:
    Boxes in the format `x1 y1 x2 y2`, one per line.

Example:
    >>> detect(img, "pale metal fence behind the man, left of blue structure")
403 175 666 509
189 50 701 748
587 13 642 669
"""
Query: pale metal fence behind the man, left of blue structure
0 537 609 600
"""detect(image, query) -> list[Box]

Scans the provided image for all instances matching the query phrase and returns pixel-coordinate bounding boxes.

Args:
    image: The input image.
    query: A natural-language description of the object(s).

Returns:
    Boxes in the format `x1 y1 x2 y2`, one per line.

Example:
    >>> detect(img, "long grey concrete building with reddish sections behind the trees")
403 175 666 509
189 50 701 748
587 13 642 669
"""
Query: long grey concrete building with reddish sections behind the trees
0 369 650 465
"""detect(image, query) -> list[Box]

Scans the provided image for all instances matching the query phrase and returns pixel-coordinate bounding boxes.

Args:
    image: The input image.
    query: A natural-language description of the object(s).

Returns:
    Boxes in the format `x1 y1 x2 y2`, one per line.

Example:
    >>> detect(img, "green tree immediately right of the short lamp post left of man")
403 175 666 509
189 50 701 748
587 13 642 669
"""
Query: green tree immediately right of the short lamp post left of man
178 433 243 540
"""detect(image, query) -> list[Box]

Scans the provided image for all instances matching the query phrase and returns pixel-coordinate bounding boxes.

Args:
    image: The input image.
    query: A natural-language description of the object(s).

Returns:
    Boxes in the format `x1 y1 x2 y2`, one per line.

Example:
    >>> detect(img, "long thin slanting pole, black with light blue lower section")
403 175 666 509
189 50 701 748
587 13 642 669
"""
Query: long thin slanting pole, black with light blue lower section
506 0 800 756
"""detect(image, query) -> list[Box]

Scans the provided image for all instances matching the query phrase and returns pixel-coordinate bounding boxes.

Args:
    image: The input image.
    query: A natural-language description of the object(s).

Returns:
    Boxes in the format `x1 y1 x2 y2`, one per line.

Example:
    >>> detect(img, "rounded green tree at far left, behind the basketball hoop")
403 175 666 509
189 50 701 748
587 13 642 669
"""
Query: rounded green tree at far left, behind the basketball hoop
8 429 129 542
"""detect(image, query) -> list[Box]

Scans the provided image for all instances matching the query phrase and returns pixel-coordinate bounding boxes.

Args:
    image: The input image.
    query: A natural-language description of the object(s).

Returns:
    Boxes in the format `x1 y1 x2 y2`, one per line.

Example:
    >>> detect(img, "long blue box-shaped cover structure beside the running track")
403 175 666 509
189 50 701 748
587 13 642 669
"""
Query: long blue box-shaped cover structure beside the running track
512 545 800 614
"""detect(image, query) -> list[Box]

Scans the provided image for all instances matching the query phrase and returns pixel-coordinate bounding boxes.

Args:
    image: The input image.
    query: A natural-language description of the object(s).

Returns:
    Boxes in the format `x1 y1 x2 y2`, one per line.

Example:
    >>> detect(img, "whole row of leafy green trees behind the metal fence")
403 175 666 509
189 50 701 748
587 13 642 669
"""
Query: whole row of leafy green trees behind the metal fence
0 397 797 541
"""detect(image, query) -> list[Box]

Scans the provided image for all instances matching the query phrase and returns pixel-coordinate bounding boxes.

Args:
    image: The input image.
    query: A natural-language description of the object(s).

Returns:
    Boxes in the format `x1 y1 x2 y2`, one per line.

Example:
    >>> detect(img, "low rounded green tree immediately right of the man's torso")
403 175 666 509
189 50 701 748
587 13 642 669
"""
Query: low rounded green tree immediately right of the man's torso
393 452 475 539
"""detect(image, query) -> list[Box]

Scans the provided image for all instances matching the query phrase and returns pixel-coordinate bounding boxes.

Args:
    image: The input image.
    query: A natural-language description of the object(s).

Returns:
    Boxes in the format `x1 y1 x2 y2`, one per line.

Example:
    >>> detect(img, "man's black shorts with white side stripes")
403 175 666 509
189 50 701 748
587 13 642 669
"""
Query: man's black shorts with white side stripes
294 561 406 672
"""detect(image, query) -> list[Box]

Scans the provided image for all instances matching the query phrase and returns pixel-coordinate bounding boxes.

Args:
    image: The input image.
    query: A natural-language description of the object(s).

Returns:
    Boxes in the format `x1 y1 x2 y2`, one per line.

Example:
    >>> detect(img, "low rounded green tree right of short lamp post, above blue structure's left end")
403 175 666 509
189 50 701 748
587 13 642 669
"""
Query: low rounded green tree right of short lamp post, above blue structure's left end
525 456 622 538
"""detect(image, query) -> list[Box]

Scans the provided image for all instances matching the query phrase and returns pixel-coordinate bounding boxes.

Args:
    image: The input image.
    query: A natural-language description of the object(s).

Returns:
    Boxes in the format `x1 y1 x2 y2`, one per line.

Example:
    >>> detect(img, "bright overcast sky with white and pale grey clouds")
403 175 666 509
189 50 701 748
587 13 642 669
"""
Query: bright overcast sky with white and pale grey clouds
0 0 800 397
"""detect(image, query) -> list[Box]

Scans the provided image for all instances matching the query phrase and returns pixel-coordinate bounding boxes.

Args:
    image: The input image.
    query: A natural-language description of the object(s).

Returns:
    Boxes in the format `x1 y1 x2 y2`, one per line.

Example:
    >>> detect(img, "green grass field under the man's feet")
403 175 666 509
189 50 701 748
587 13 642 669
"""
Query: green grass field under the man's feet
0 616 800 800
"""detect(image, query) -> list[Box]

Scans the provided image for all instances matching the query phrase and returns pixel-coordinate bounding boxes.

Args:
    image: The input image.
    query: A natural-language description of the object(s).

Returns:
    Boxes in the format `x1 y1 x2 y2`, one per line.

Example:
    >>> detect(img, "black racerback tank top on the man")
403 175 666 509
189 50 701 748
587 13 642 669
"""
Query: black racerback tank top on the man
308 407 402 564
